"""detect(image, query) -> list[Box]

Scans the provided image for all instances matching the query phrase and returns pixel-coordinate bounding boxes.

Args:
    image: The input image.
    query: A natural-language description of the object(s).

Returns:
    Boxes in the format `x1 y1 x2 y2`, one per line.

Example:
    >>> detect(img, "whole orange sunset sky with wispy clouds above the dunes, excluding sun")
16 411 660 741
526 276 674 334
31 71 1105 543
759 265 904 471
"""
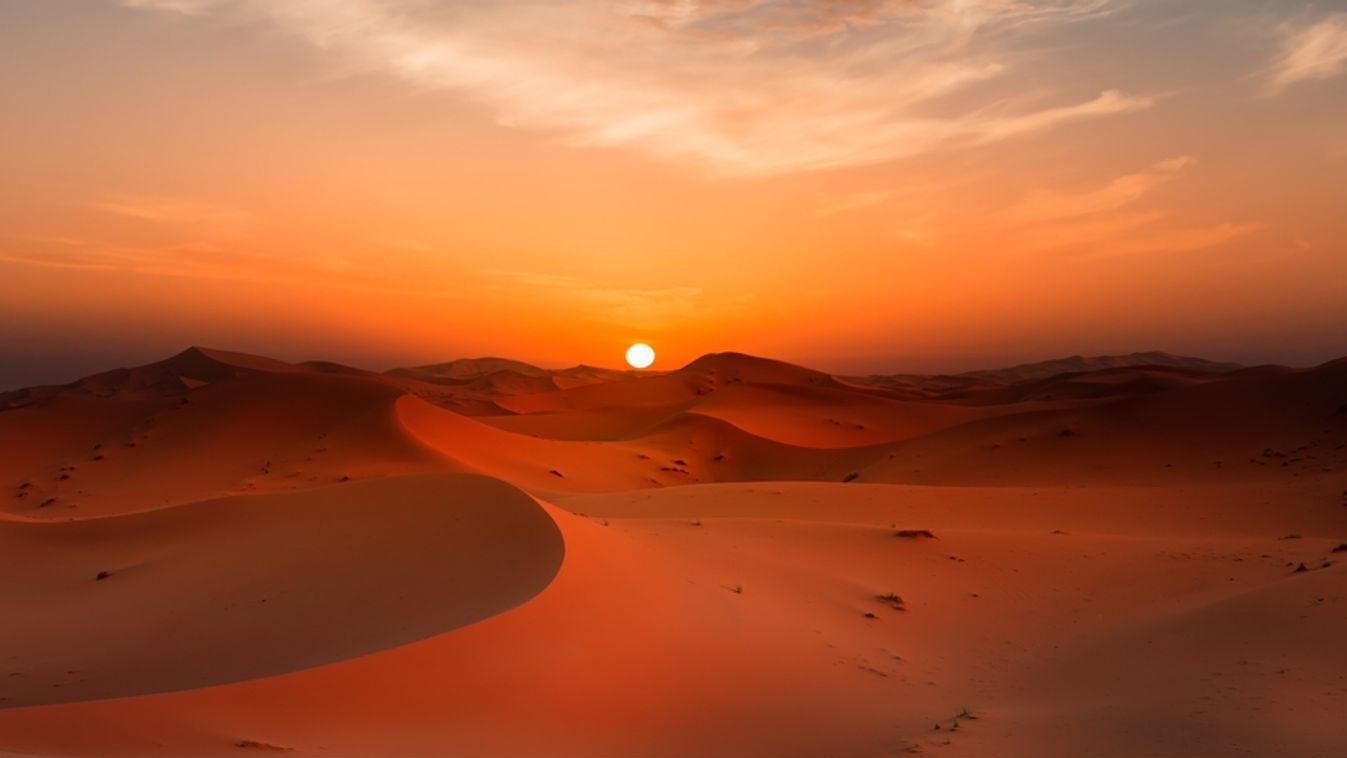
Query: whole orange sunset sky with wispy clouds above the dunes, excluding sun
0 0 1347 388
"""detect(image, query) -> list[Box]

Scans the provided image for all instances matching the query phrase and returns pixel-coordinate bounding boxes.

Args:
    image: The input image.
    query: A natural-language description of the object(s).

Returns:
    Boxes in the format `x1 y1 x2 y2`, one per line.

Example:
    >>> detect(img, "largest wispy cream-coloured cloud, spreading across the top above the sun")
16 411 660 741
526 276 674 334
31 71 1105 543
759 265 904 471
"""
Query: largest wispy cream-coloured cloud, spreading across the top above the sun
123 0 1152 176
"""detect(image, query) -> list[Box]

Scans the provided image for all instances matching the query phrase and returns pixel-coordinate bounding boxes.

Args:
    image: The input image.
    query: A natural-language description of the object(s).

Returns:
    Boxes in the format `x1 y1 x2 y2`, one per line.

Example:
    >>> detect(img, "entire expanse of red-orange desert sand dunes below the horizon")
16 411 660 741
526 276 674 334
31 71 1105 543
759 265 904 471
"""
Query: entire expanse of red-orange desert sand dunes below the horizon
0 347 1347 757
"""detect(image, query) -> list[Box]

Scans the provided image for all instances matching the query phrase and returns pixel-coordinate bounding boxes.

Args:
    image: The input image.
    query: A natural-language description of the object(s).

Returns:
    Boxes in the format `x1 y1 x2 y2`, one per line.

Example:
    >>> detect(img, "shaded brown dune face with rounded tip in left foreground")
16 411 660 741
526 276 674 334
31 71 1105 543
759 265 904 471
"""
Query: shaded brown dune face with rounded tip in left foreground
0 474 563 708
